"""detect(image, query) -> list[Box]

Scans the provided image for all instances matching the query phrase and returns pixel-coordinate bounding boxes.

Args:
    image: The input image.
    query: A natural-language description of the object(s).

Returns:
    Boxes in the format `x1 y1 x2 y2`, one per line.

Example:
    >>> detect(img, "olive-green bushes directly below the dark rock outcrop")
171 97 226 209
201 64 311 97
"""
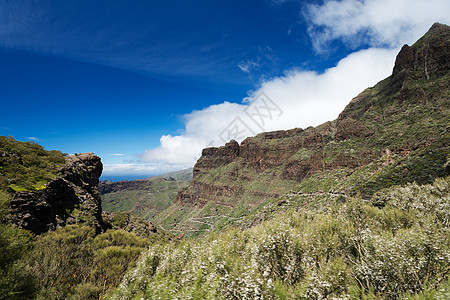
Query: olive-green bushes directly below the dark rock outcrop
28 225 150 299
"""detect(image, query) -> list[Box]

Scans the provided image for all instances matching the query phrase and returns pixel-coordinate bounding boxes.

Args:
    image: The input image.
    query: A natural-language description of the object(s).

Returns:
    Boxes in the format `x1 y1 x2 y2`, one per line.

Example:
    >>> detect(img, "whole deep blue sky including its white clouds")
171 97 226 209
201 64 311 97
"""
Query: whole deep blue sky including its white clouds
0 0 450 178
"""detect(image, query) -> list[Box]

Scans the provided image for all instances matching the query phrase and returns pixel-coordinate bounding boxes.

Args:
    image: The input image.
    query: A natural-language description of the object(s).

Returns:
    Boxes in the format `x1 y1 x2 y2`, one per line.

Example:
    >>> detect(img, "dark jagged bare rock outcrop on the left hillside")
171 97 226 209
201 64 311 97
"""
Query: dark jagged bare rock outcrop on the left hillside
11 153 104 234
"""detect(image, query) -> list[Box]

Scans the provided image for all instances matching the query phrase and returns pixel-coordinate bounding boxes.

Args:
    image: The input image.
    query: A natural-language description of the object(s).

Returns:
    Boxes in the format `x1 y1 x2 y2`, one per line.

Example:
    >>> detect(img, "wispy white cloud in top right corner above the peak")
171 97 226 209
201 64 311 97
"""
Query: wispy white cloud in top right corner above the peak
304 0 450 51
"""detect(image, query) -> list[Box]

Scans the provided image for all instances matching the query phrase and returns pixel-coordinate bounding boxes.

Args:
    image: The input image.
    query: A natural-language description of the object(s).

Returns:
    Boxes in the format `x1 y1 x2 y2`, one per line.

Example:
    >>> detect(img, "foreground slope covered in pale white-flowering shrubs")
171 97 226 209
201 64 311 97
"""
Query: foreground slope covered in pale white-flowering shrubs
112 177 450 299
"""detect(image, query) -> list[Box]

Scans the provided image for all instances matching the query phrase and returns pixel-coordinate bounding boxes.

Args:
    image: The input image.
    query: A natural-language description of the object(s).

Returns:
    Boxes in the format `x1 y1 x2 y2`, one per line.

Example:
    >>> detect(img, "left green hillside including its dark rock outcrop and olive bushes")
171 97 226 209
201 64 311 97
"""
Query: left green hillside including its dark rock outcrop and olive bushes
0 136 173 300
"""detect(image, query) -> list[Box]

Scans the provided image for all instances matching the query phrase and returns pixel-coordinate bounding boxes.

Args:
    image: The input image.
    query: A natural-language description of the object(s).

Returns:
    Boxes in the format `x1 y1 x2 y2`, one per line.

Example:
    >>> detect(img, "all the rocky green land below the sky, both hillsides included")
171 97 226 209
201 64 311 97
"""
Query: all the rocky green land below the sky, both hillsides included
0 23 450 299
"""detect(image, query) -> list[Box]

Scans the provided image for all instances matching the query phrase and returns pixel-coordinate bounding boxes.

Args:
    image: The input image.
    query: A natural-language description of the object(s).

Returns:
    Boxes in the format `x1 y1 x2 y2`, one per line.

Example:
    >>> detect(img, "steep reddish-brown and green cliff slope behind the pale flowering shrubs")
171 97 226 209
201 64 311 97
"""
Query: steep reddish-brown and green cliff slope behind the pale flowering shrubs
160 23 450 233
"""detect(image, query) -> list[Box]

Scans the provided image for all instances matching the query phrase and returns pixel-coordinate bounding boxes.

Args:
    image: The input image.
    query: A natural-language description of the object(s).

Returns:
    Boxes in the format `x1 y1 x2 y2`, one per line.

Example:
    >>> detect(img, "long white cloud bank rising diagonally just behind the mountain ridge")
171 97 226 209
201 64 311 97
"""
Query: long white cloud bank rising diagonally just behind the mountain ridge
141 49 398 167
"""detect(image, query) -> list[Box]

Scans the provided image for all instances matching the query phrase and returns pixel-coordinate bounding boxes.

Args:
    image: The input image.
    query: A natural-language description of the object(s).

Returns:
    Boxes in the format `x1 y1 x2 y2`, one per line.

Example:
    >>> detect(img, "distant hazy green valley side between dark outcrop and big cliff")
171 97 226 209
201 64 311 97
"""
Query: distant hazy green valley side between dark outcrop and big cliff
98 169 192 221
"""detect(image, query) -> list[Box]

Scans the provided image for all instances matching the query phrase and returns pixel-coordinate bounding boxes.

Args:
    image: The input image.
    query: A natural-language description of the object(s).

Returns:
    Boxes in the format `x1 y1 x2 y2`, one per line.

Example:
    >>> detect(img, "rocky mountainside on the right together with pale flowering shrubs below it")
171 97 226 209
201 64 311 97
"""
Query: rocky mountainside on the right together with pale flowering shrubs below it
108 24 450 299
